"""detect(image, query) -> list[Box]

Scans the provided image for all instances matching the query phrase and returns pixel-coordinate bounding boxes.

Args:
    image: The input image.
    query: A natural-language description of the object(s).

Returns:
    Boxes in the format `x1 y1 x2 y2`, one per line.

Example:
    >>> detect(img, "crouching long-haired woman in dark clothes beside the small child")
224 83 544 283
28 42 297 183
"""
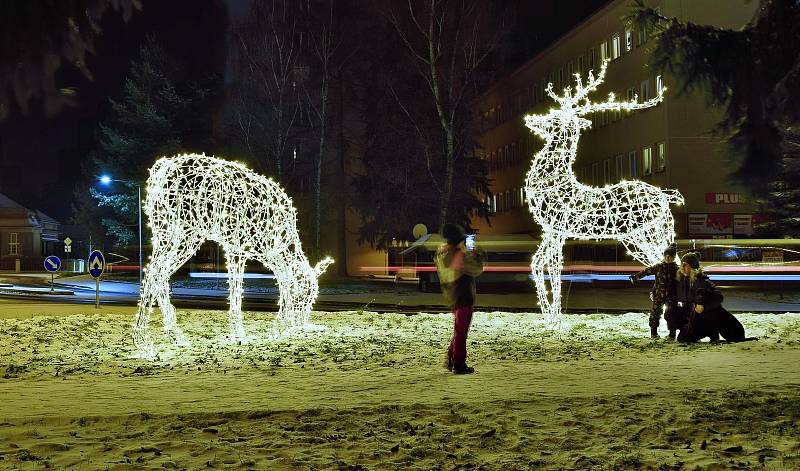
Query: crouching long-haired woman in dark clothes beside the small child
677 252 745 343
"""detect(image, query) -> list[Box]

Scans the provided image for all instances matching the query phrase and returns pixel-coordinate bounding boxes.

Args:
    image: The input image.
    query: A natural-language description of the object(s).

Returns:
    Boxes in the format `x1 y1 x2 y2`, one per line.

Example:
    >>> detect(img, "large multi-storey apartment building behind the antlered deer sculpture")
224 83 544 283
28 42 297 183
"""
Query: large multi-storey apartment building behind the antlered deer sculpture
473 0 760 239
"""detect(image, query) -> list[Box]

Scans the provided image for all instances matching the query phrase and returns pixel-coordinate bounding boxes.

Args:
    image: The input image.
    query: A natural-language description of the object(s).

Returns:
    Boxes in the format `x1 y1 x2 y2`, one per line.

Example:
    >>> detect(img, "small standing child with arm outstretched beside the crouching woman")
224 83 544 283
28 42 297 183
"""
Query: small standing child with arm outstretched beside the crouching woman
630 245 683 339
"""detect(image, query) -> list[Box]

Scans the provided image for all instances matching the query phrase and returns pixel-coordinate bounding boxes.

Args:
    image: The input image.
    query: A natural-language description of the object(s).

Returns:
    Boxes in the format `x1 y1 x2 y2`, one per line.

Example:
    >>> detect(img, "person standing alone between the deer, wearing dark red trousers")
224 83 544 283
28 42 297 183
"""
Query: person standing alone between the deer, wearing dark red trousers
434 224 483 374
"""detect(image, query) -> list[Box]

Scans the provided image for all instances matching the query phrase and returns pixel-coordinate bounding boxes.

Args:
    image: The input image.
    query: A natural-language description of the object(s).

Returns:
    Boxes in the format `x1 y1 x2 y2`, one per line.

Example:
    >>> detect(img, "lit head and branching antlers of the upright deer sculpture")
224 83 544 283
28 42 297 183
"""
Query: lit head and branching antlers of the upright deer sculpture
525 60 666 141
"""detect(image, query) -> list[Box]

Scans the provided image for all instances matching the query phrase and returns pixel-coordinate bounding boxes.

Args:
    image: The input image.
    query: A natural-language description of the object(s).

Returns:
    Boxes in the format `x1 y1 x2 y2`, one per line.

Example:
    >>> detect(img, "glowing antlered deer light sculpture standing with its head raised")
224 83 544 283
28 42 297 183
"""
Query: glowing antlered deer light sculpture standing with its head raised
525 61 683 329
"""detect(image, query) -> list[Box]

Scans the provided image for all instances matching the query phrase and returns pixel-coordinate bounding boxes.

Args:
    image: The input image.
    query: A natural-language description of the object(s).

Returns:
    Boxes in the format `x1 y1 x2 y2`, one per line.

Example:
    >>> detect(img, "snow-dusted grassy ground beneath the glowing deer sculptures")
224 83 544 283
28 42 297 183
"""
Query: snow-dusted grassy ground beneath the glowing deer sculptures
0 303 800 470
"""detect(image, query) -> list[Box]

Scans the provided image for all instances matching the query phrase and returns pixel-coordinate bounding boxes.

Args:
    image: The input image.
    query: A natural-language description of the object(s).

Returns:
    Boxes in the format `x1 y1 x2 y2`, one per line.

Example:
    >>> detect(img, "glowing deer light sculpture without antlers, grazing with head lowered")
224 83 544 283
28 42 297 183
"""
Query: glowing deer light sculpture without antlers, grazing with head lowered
133 154 333 358
